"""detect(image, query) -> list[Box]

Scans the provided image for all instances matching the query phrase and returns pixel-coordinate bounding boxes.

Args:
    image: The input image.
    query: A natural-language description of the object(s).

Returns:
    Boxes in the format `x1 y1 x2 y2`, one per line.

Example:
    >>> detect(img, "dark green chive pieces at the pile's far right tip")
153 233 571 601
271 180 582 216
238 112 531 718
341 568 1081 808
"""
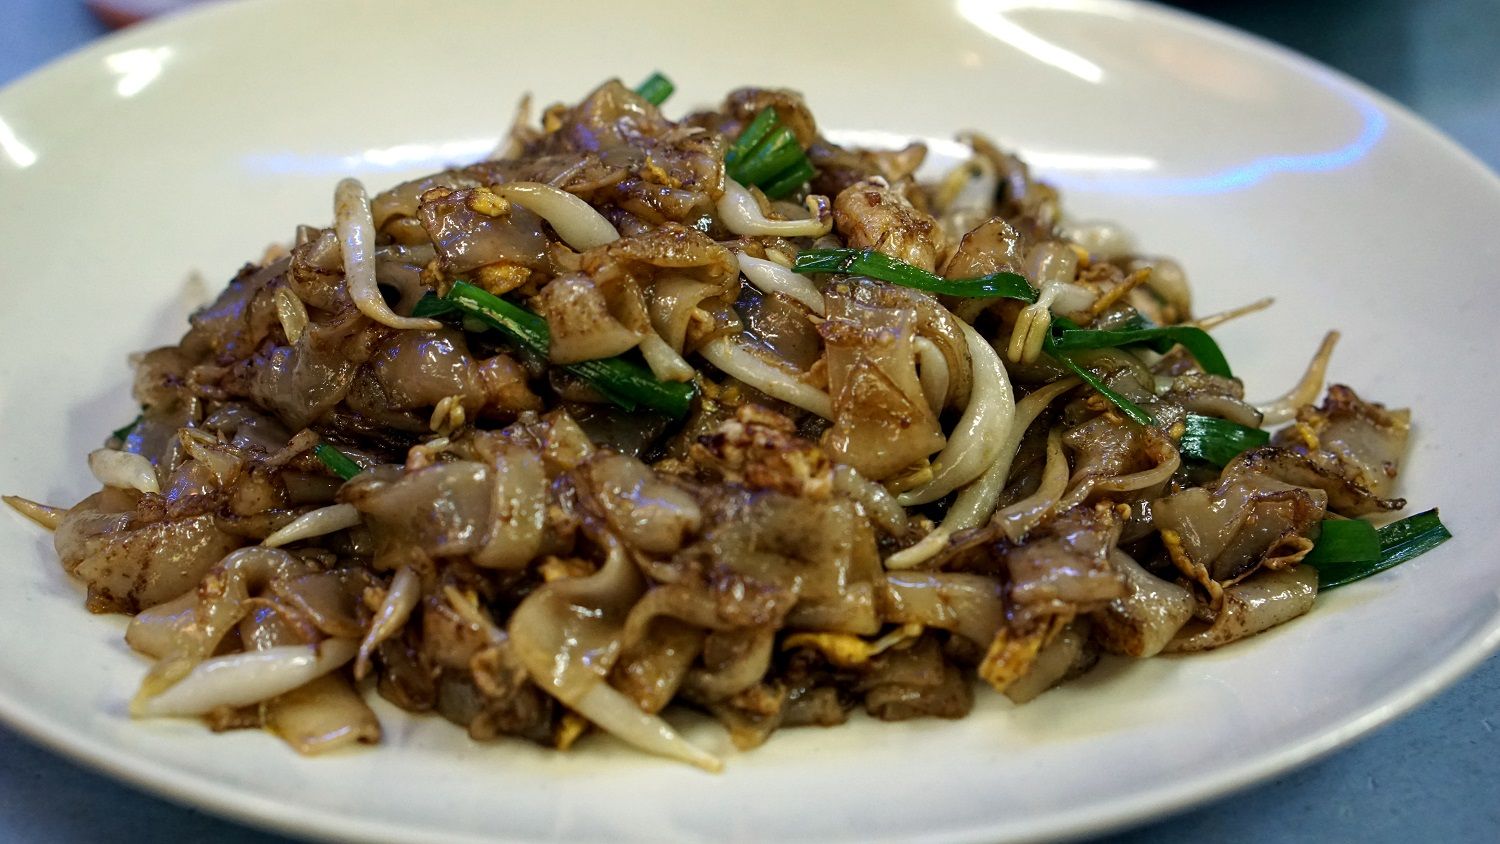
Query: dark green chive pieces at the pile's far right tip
1302 510 1454 592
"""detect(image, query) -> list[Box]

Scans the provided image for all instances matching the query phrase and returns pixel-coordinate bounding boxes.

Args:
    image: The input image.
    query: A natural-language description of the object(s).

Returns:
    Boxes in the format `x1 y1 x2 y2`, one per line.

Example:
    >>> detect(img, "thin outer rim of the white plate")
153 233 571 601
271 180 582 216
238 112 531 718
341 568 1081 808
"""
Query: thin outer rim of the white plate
0 0 1500 844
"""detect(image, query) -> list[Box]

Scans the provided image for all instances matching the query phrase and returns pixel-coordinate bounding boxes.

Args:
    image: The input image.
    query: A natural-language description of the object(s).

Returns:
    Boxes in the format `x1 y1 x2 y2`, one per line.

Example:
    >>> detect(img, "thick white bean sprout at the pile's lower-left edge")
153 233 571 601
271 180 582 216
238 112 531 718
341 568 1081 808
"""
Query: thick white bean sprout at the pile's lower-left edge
131 639 359 718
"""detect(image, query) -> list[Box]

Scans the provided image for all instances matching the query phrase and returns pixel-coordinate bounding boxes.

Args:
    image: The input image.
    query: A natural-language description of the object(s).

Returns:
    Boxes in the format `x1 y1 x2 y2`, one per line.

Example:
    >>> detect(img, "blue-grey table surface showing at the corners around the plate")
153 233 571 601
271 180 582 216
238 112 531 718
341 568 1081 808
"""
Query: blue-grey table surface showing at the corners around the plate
0 0 1500 844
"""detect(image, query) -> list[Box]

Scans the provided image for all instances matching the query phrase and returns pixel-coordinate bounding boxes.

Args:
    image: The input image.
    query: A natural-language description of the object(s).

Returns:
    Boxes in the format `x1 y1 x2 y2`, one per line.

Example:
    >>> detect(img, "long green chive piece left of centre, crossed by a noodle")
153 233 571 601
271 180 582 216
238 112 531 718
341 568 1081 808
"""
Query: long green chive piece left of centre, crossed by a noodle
413 282 693 418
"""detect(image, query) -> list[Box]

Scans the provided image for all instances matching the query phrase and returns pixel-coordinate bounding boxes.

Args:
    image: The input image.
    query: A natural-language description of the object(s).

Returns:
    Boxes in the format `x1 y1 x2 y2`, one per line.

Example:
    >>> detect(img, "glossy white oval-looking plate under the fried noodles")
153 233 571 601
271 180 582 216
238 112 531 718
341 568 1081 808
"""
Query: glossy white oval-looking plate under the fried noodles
0 0 1500 841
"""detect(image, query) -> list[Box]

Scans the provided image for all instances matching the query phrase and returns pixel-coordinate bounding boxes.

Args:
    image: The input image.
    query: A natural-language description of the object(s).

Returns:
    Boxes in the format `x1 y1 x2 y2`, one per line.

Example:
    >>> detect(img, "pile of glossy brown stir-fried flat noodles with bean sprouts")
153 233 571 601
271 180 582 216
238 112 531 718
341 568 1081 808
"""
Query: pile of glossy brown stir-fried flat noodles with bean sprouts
12 82 1409 769
